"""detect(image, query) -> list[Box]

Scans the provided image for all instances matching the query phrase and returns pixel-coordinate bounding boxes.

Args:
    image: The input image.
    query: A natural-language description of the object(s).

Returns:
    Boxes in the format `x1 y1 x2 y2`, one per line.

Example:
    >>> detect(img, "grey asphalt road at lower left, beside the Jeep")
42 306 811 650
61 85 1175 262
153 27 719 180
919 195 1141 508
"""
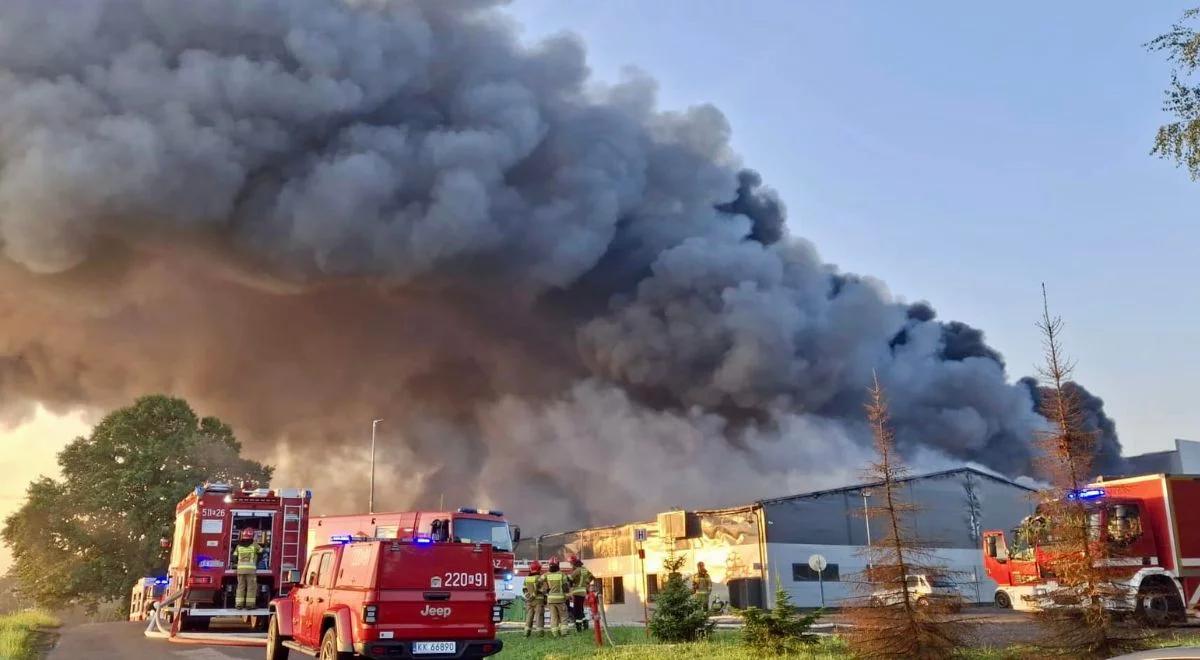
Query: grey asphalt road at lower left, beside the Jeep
49 623 265 660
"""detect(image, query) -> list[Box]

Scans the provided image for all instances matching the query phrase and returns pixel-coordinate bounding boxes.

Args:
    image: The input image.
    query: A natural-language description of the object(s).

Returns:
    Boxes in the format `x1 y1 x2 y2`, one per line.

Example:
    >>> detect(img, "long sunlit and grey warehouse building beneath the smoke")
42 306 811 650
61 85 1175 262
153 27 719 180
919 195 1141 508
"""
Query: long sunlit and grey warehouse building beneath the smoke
517 468 1033 623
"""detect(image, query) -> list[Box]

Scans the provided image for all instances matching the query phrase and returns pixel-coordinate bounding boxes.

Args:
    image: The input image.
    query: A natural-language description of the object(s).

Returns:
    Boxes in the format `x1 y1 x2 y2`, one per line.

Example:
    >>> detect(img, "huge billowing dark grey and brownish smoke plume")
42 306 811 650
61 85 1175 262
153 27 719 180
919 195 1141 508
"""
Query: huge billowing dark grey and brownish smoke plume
0 0 1118 527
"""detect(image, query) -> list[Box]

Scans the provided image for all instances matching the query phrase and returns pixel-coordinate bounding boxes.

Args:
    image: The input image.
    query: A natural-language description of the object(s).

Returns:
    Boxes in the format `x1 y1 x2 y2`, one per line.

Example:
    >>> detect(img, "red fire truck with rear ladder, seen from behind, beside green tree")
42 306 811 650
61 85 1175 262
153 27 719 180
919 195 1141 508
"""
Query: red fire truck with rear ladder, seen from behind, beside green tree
163 484 312 632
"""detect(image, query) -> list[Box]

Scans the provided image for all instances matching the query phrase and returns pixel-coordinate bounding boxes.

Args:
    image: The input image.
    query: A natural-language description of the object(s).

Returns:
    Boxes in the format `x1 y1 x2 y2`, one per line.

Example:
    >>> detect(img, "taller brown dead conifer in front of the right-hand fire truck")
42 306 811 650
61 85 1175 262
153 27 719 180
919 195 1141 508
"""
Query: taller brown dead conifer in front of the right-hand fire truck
1022 284 1146 658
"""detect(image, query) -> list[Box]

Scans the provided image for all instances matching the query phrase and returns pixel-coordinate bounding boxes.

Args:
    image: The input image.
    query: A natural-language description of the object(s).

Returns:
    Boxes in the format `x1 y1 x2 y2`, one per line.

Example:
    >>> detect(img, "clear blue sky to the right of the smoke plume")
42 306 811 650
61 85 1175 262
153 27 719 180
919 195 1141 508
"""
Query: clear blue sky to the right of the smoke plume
510 0 1200 454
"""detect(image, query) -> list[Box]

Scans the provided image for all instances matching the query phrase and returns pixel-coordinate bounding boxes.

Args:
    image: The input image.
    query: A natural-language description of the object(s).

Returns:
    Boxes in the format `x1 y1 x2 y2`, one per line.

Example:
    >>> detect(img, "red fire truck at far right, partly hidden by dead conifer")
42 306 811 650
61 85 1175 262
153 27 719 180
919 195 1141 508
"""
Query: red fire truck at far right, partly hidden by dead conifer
983 474 1200 624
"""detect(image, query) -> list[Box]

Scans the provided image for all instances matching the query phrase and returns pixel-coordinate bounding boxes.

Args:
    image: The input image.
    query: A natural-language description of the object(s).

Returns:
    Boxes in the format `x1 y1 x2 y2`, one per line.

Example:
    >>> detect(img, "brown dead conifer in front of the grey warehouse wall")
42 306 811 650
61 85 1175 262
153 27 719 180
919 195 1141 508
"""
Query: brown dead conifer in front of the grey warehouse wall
846 377 970 659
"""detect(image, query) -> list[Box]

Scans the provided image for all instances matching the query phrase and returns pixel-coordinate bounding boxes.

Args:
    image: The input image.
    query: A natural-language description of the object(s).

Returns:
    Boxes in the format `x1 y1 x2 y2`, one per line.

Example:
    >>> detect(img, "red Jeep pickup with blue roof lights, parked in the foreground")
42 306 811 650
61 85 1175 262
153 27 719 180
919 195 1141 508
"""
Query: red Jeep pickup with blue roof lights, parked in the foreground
266 539 502 660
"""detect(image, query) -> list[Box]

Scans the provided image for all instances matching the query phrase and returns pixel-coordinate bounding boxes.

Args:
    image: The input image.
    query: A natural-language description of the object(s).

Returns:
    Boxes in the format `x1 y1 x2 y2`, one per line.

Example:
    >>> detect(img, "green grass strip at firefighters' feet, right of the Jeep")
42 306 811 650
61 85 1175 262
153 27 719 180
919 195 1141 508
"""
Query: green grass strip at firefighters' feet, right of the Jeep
499 628 846 660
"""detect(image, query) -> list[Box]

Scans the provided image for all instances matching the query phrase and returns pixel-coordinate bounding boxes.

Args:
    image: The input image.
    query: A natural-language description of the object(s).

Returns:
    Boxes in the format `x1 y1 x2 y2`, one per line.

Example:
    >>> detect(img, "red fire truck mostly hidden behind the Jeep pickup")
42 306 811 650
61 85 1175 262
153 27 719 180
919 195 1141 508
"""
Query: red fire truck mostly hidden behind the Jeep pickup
308 508 521 606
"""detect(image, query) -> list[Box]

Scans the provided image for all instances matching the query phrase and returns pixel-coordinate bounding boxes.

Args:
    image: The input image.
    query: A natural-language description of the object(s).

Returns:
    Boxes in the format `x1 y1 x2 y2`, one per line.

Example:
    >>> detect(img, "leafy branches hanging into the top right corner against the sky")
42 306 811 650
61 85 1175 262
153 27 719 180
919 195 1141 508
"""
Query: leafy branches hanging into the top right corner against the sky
1146 10 1200 179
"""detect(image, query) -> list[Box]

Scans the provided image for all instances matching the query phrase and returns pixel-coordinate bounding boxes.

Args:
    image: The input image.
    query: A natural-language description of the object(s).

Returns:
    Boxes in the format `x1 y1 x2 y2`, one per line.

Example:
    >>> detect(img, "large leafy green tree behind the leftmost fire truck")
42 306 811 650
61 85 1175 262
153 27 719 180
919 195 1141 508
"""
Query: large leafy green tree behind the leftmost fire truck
2 395 271 610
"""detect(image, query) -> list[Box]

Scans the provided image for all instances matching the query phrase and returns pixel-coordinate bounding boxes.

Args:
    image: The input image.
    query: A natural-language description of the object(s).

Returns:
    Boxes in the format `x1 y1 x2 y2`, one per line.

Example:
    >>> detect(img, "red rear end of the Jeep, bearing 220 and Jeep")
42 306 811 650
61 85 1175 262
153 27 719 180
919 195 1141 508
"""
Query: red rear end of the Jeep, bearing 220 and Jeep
374 542 496 640
